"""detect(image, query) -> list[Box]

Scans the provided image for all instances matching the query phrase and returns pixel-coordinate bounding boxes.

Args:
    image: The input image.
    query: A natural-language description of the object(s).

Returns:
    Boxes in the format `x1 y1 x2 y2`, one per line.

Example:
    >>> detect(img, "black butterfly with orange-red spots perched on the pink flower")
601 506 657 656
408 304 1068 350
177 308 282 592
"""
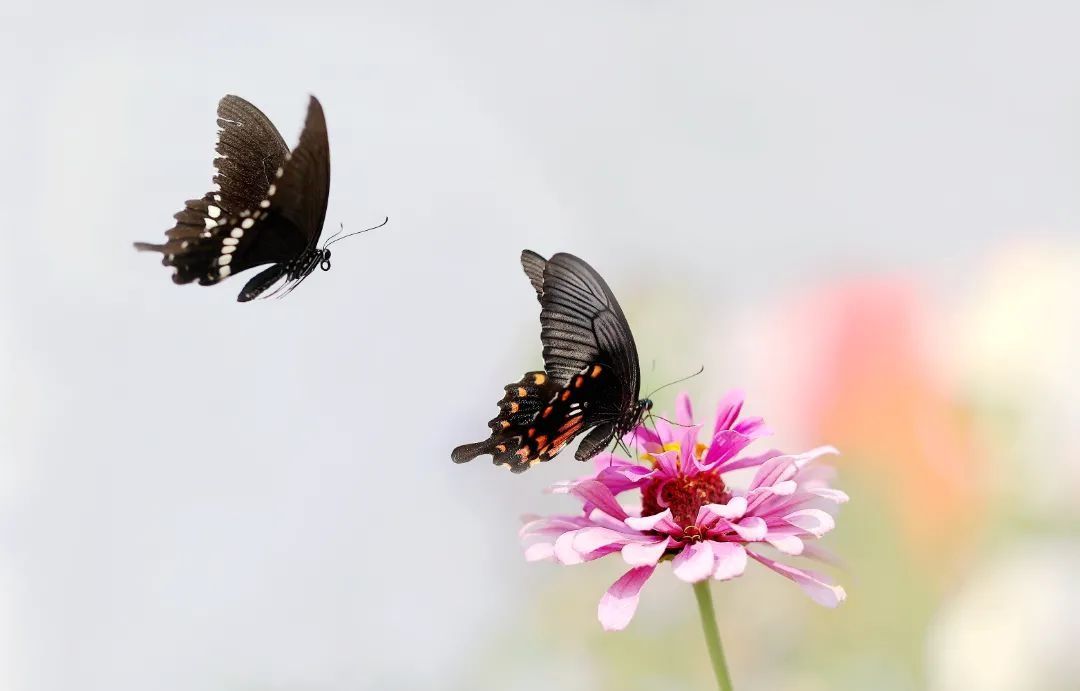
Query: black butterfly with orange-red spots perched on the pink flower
450 249 652 473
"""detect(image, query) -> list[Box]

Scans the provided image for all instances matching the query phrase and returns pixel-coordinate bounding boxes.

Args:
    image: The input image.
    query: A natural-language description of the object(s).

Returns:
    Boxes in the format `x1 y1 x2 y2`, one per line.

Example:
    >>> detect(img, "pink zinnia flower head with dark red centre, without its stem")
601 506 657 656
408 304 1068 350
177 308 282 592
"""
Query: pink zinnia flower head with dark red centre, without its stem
521 392 848 631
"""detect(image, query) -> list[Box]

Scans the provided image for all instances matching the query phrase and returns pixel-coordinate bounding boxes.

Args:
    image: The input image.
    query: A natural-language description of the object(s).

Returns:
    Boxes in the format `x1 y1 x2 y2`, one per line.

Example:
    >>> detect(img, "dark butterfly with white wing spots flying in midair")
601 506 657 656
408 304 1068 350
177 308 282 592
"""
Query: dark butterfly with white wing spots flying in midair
135 95 386 302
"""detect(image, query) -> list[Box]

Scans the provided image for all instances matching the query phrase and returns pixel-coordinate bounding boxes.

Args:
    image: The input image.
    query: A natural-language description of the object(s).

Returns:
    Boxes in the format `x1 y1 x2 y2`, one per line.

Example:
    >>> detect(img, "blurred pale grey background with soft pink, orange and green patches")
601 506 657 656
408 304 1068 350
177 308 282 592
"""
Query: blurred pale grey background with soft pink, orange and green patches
0 0 1080 691
